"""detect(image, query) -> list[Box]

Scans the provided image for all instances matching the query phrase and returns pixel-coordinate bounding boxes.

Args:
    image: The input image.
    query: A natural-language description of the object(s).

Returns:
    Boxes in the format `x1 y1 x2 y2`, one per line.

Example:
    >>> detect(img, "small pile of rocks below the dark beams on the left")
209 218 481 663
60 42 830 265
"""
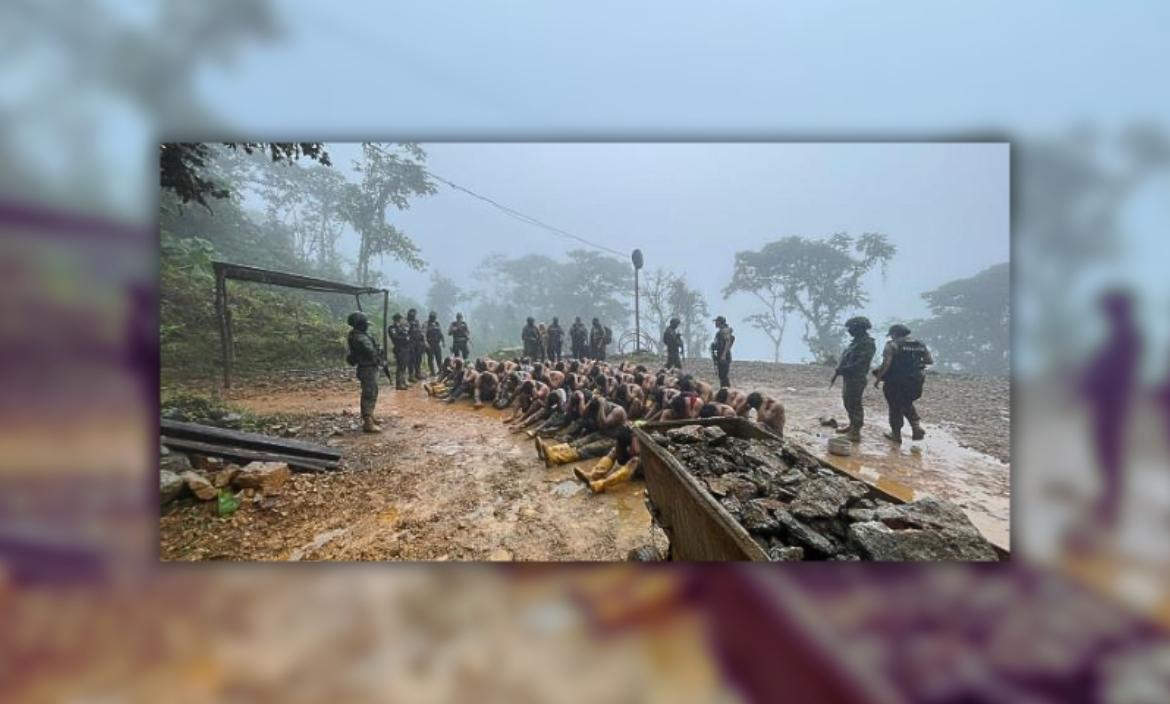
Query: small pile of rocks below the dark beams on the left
159 453 291 505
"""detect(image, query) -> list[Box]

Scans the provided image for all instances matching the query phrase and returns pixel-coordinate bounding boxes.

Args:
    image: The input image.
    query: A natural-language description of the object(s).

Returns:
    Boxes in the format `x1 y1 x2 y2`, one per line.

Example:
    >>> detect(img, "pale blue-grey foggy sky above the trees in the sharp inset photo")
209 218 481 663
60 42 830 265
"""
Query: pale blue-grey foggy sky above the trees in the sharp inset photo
318 143 1010 361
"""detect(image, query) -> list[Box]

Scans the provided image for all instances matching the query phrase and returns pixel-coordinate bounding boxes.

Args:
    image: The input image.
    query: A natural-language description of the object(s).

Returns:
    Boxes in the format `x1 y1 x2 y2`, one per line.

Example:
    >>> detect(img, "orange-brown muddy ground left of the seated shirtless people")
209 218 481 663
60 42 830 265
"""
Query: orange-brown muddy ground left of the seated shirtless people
160 371 666 560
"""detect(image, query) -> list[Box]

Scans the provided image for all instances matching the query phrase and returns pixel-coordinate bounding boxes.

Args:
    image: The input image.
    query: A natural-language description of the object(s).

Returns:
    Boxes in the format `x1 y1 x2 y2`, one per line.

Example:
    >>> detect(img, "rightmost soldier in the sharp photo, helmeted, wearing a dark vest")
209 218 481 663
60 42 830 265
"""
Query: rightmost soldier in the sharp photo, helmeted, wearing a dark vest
874 323 935 442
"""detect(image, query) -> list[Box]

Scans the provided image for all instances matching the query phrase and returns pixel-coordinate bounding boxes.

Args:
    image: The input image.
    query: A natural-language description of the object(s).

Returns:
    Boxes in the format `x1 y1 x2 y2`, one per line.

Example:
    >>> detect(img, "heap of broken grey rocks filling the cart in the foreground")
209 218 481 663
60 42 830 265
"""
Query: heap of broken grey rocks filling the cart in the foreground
653 426 998 561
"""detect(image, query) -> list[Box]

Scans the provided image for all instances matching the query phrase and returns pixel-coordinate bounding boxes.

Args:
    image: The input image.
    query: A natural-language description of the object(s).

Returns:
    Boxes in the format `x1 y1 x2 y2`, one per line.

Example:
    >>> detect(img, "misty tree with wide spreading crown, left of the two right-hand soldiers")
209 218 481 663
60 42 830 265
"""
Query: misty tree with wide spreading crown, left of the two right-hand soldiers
723 233 897 361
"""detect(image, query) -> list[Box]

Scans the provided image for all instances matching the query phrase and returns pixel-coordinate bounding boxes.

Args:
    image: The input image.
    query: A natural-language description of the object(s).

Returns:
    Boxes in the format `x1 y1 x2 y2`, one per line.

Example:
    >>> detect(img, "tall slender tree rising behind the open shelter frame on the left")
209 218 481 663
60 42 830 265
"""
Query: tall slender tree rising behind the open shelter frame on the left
340 143 436 285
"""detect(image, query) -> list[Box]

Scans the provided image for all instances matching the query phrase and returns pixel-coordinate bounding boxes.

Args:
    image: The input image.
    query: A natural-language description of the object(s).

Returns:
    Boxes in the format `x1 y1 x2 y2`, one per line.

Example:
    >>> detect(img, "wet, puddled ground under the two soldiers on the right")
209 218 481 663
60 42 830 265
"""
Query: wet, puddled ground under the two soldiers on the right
734 363 1011 548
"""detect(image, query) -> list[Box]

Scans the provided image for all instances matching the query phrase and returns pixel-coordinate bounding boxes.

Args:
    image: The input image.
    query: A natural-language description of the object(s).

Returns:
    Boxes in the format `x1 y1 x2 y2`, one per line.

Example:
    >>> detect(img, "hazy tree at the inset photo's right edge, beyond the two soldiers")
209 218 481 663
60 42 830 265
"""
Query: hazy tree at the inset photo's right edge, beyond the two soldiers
911 263 1011 374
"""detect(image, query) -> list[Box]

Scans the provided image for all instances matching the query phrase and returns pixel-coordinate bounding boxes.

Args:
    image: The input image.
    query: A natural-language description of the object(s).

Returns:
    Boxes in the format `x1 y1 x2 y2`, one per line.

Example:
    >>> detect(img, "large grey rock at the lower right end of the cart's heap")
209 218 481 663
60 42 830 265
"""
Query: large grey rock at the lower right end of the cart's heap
848 498 999 562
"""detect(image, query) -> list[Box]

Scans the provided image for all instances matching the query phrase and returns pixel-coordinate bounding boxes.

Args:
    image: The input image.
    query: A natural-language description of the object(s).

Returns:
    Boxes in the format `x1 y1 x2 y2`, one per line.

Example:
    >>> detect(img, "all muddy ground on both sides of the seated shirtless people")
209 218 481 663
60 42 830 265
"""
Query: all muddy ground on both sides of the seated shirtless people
160 360 1010 560
